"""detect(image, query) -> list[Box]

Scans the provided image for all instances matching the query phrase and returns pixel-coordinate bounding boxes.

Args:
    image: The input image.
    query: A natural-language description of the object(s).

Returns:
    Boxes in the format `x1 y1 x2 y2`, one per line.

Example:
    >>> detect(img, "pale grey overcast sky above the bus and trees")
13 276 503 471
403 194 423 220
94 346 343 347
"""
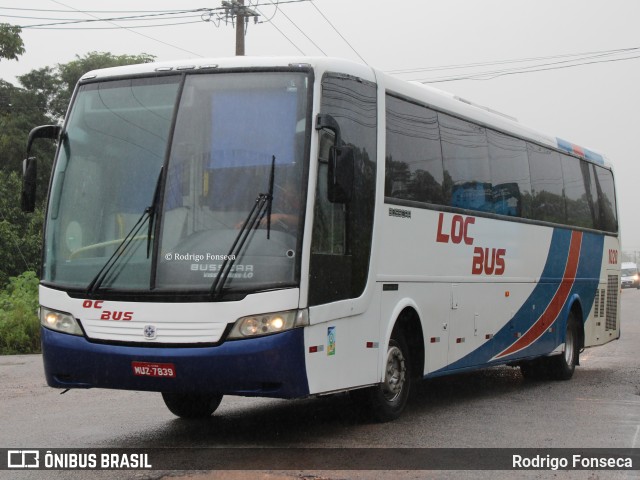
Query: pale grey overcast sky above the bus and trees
0 0 640 254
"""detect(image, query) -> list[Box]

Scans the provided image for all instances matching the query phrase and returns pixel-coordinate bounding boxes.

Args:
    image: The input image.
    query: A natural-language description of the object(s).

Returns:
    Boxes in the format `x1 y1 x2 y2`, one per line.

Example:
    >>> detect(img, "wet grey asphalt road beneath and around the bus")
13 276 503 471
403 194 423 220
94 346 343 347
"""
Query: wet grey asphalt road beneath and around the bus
0 290 640 480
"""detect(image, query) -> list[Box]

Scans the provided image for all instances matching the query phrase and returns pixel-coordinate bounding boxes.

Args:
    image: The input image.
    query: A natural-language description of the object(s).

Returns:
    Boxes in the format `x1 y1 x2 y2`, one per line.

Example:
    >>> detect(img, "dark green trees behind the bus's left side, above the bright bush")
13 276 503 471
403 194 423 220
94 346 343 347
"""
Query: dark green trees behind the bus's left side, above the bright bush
0 50 154 288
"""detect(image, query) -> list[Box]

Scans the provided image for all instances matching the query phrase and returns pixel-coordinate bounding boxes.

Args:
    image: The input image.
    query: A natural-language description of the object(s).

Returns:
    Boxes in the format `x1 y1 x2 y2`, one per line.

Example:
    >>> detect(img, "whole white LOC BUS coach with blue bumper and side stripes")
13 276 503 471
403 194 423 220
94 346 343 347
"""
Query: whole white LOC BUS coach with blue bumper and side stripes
23 57 620 421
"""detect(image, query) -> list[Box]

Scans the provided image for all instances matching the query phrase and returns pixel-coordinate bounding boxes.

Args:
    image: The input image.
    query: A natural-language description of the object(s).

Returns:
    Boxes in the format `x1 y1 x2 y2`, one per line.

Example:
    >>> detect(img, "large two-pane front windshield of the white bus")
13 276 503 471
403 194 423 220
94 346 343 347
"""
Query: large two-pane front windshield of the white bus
43 72 309 293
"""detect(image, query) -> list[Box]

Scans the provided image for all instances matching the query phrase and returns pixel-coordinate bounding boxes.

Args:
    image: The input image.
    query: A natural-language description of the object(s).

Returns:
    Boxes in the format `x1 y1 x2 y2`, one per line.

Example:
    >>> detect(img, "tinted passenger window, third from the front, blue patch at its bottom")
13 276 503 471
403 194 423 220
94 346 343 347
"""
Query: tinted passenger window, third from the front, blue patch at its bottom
487 130 531 217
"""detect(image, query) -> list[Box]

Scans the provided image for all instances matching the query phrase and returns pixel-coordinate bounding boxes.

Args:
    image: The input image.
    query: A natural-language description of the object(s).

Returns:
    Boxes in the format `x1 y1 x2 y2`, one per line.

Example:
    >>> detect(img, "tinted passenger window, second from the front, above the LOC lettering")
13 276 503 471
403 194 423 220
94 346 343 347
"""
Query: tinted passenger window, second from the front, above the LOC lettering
438 113 493 212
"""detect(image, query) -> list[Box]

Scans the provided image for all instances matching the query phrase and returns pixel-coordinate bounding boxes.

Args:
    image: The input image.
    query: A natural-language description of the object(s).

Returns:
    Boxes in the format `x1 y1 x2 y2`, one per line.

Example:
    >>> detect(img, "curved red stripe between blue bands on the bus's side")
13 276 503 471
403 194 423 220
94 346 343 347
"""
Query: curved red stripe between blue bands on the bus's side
494 232 582 359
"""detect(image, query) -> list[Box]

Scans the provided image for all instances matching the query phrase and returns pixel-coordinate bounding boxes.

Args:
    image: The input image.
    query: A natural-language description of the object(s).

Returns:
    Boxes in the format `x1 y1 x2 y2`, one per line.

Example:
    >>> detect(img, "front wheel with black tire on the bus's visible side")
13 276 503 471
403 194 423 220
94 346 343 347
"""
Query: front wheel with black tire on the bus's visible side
351 335 412 422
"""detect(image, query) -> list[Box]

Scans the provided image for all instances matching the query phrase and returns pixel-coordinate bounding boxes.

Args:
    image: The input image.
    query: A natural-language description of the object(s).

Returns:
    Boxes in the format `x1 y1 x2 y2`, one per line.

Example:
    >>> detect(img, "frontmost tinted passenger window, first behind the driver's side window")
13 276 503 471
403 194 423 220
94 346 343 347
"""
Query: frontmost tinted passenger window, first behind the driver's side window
385 95 444 204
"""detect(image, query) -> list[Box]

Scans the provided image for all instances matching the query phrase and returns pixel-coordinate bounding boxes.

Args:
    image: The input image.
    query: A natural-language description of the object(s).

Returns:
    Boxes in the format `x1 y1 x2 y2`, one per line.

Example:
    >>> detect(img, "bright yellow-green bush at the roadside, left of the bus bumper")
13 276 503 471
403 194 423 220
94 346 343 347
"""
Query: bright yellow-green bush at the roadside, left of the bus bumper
0 271 40 355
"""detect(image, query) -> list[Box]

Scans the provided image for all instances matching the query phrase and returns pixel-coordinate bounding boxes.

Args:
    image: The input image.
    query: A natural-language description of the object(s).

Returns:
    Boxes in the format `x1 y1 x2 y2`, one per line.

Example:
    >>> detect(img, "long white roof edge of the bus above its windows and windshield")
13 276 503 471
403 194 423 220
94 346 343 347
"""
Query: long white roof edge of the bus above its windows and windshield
81 56 611 168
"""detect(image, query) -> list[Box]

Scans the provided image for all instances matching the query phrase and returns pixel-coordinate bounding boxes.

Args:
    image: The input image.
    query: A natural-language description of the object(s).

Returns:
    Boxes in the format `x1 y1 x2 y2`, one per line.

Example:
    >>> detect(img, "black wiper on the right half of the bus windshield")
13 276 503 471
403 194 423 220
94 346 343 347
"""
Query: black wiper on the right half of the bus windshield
210 155 276 299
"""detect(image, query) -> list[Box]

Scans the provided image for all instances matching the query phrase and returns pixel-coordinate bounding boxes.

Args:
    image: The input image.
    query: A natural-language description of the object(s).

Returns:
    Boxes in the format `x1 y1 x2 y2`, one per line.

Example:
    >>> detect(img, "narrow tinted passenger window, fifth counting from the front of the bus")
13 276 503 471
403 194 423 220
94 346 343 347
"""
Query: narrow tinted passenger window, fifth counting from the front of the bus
561 155 594 228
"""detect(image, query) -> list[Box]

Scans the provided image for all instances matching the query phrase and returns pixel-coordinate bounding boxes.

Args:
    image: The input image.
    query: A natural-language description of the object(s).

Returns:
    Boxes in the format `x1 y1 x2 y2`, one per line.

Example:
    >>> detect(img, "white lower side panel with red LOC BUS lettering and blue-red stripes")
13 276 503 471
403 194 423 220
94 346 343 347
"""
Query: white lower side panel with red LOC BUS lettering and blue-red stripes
379 205 619 375
